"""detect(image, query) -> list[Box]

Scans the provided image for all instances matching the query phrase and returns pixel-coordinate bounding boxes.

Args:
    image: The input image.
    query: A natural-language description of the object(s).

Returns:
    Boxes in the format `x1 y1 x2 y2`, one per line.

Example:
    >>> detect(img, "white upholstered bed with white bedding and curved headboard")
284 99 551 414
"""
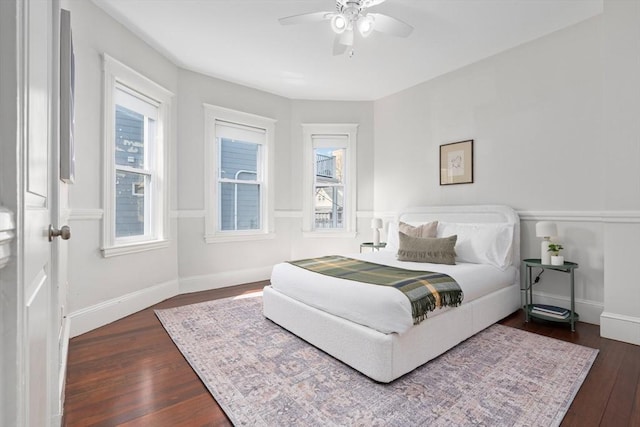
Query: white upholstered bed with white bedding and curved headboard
263 205 521 383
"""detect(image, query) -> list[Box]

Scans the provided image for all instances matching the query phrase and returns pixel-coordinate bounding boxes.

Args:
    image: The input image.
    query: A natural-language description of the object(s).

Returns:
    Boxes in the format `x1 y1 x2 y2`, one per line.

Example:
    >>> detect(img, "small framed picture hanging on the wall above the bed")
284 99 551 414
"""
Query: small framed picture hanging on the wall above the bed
440 139 473 185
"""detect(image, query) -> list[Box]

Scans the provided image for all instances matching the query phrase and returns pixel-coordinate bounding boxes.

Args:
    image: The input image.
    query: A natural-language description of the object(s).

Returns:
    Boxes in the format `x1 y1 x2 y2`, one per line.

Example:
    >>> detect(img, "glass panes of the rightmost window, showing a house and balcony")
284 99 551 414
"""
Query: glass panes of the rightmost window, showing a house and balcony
314 148 346 229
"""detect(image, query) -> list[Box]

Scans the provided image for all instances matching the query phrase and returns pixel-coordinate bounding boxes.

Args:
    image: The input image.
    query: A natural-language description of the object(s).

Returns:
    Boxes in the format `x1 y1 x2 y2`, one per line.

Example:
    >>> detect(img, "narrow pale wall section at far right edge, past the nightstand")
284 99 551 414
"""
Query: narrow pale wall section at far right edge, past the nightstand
601 0 640 345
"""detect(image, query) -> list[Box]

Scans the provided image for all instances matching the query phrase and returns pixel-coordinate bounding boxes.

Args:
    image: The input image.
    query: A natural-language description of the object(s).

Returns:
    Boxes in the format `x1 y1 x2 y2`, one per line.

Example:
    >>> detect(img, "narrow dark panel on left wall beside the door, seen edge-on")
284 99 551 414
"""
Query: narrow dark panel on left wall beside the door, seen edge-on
60 9 75 184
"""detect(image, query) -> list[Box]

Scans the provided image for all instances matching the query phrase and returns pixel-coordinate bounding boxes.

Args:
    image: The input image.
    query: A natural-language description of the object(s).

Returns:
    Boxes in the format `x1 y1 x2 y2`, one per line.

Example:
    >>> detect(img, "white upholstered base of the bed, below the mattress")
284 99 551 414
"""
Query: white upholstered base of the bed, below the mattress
263 284 521 383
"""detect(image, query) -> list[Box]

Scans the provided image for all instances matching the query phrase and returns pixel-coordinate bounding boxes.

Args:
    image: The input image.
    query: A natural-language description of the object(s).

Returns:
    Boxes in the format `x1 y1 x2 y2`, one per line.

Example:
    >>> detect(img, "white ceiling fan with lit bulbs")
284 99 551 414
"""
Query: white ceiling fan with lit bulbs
278 0 413 56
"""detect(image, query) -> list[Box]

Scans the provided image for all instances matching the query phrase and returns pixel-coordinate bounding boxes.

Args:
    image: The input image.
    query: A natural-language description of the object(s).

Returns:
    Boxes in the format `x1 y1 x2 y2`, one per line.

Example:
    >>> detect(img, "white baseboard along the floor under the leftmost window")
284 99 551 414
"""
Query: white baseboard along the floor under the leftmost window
69 280 179 338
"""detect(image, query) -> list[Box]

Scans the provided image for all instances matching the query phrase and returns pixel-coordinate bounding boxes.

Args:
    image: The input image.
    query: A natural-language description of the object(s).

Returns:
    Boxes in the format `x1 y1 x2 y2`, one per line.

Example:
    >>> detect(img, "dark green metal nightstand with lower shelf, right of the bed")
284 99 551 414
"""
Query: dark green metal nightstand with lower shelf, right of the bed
522 258 580 332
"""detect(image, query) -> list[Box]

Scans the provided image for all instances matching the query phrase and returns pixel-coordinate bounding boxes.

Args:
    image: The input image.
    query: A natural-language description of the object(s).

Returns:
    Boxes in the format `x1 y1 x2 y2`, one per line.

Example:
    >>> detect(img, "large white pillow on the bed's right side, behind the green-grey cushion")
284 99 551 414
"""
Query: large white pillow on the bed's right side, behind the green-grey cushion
438 222 514 270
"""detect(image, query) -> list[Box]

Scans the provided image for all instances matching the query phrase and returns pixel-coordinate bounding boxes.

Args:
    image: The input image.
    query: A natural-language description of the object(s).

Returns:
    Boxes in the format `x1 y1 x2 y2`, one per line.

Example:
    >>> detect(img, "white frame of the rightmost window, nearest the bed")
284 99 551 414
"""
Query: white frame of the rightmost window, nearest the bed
302 123 358 238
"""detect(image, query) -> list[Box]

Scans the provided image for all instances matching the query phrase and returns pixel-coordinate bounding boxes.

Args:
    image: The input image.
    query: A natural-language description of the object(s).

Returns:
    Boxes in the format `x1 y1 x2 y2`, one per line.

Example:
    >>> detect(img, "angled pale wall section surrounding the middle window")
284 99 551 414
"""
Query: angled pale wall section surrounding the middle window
178 70 291 292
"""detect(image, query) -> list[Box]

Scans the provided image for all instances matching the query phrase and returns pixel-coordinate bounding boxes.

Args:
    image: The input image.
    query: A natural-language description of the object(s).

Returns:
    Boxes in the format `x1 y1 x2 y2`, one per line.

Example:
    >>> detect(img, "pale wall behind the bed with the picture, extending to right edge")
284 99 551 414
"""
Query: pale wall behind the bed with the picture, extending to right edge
374 0 640 338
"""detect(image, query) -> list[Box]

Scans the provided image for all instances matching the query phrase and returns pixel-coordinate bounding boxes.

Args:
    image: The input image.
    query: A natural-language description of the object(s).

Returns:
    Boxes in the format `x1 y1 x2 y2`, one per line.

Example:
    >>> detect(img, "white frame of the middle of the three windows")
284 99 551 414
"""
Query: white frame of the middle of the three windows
203 104 276 243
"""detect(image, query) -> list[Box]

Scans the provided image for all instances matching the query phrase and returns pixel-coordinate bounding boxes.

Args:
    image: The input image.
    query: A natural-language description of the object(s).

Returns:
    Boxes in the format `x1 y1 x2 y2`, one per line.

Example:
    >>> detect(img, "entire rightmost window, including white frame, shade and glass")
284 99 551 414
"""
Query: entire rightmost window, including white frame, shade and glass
303 124 357 236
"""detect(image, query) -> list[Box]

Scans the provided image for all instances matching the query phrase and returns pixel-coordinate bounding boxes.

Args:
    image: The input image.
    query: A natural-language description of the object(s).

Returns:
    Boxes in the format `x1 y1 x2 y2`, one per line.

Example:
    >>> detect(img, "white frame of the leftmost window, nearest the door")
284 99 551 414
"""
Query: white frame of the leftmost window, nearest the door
102 54 174 257
